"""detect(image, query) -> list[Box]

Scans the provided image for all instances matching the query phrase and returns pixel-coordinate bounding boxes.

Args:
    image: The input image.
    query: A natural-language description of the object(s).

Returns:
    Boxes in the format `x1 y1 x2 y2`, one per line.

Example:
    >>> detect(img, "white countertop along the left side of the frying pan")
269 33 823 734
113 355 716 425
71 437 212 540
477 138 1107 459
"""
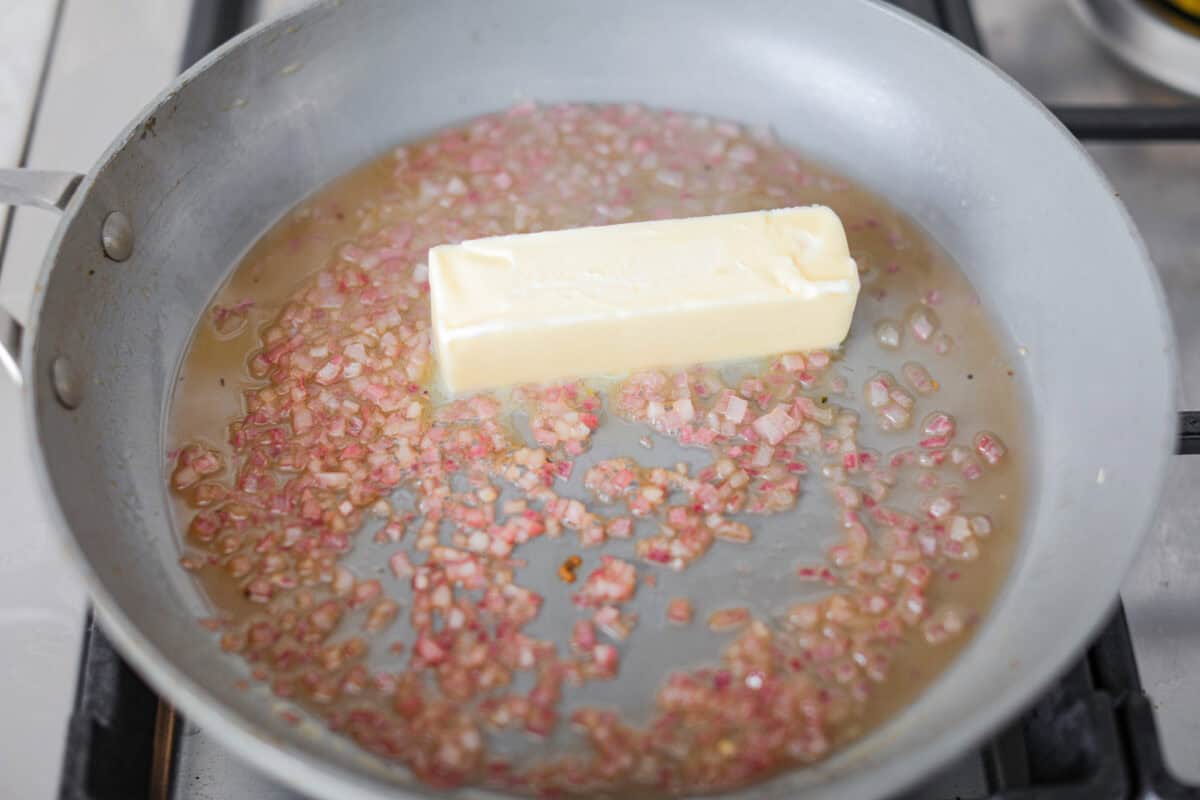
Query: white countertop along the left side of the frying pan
0 0 191 800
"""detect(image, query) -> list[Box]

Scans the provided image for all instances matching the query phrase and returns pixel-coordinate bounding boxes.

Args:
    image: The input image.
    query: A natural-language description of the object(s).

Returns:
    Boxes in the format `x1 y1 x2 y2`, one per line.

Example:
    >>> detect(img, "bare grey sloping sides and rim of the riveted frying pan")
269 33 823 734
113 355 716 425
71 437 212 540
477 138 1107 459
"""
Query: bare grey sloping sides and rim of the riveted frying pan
0 0 1175 798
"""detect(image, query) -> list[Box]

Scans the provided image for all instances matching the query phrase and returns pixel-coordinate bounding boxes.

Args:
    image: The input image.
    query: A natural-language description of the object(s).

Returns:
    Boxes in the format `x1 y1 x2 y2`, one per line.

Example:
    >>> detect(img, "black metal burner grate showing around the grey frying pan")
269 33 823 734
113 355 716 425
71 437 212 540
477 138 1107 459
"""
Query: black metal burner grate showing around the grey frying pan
59 0 1200 800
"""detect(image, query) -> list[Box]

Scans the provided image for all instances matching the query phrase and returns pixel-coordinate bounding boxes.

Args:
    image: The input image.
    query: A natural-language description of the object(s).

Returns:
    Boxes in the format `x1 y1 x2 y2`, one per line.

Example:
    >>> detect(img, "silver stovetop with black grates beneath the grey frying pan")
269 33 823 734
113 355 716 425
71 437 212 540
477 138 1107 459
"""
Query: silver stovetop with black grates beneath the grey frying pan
18 0 1200 800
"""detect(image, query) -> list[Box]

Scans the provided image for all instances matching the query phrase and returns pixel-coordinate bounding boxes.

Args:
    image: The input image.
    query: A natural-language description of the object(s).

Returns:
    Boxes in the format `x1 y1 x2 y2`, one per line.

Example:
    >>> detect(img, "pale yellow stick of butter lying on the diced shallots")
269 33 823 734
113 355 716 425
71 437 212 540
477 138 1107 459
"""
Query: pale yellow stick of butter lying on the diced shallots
430 205 859 392
